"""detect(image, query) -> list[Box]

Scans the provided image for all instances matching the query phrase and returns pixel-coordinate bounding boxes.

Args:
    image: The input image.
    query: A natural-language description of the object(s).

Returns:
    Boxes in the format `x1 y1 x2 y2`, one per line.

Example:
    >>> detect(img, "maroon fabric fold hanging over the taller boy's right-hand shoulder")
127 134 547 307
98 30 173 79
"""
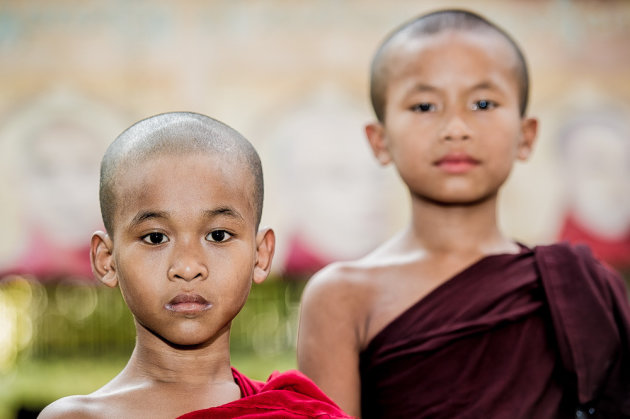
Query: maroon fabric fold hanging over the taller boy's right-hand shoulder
536 244 630 418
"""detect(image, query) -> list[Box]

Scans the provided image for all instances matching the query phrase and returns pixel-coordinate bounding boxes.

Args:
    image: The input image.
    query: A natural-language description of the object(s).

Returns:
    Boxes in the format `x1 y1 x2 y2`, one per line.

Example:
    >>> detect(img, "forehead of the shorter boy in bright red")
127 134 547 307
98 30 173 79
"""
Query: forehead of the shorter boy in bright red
114 153 255 230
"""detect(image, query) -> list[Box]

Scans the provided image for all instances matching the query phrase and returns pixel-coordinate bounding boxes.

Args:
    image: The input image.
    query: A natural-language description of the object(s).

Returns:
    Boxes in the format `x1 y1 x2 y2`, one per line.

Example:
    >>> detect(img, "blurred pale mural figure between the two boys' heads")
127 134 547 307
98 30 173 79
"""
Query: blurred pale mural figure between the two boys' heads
266 86 391 276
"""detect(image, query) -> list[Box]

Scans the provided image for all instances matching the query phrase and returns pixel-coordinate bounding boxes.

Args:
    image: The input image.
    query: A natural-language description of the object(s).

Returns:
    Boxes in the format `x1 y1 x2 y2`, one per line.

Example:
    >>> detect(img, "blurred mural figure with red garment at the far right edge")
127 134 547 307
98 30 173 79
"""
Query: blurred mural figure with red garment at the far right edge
558 109 630 279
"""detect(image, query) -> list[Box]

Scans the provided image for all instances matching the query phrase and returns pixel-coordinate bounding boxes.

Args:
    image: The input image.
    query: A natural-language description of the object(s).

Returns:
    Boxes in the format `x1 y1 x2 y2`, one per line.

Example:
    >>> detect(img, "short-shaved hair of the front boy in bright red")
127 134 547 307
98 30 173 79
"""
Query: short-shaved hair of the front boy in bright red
99 112 264 235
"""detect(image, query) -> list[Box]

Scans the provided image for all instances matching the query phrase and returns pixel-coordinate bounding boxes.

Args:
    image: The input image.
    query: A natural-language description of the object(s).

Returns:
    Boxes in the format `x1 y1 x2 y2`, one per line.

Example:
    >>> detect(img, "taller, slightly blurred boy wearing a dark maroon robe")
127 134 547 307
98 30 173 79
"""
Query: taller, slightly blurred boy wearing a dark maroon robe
298 10 630 419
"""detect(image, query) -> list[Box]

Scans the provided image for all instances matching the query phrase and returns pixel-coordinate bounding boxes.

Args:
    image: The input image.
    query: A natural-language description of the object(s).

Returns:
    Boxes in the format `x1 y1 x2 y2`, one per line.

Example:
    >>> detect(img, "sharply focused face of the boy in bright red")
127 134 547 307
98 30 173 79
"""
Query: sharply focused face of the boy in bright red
103 154 257 345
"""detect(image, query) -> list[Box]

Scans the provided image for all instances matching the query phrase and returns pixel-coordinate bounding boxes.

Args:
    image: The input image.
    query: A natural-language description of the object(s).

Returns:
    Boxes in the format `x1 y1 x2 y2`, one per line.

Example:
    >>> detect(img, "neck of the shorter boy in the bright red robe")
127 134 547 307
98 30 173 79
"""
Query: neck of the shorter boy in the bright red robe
123 323 234 387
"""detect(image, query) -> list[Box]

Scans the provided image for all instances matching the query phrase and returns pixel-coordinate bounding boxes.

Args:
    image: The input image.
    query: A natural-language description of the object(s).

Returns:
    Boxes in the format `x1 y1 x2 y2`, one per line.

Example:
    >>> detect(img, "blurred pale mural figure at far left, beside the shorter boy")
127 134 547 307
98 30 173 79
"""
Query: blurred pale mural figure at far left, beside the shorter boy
0 91 124 280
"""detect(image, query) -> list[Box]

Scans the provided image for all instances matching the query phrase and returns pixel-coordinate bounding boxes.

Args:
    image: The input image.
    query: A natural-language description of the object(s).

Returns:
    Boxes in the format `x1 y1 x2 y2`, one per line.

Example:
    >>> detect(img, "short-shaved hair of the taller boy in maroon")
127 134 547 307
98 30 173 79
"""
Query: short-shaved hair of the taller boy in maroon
370 10 529 122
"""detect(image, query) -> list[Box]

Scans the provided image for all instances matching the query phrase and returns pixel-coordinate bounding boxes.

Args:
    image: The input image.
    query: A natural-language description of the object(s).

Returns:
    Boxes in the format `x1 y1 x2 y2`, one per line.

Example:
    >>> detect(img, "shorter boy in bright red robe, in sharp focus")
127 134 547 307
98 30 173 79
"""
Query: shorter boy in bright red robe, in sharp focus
41 113 356 418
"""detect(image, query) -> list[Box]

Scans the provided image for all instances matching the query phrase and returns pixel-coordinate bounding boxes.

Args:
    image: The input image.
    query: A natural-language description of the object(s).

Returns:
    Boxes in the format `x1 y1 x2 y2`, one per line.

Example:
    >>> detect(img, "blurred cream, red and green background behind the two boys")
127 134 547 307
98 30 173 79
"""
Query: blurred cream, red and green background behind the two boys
0 0 630 418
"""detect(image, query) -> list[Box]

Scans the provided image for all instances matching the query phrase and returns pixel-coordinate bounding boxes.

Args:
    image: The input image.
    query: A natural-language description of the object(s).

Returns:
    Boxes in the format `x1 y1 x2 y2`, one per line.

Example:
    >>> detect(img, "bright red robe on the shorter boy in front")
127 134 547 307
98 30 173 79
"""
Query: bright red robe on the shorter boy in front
178 368 351 419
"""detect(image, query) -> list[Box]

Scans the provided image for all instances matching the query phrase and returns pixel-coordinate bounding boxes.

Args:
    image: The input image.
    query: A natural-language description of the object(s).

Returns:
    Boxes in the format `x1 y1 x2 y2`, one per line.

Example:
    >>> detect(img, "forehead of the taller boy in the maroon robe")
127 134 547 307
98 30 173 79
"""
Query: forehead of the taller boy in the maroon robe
386 30 518 89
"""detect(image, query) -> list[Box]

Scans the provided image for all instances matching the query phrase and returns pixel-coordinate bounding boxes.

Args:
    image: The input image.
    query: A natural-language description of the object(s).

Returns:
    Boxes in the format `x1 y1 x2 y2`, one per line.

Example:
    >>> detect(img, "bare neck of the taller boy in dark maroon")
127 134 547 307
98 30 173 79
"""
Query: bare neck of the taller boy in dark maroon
407 195 518 255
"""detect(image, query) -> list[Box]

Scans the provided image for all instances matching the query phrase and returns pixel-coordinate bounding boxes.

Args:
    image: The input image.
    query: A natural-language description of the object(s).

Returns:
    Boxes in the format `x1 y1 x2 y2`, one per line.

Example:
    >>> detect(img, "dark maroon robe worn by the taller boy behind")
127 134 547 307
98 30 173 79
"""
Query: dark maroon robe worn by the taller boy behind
360 245 630 419
